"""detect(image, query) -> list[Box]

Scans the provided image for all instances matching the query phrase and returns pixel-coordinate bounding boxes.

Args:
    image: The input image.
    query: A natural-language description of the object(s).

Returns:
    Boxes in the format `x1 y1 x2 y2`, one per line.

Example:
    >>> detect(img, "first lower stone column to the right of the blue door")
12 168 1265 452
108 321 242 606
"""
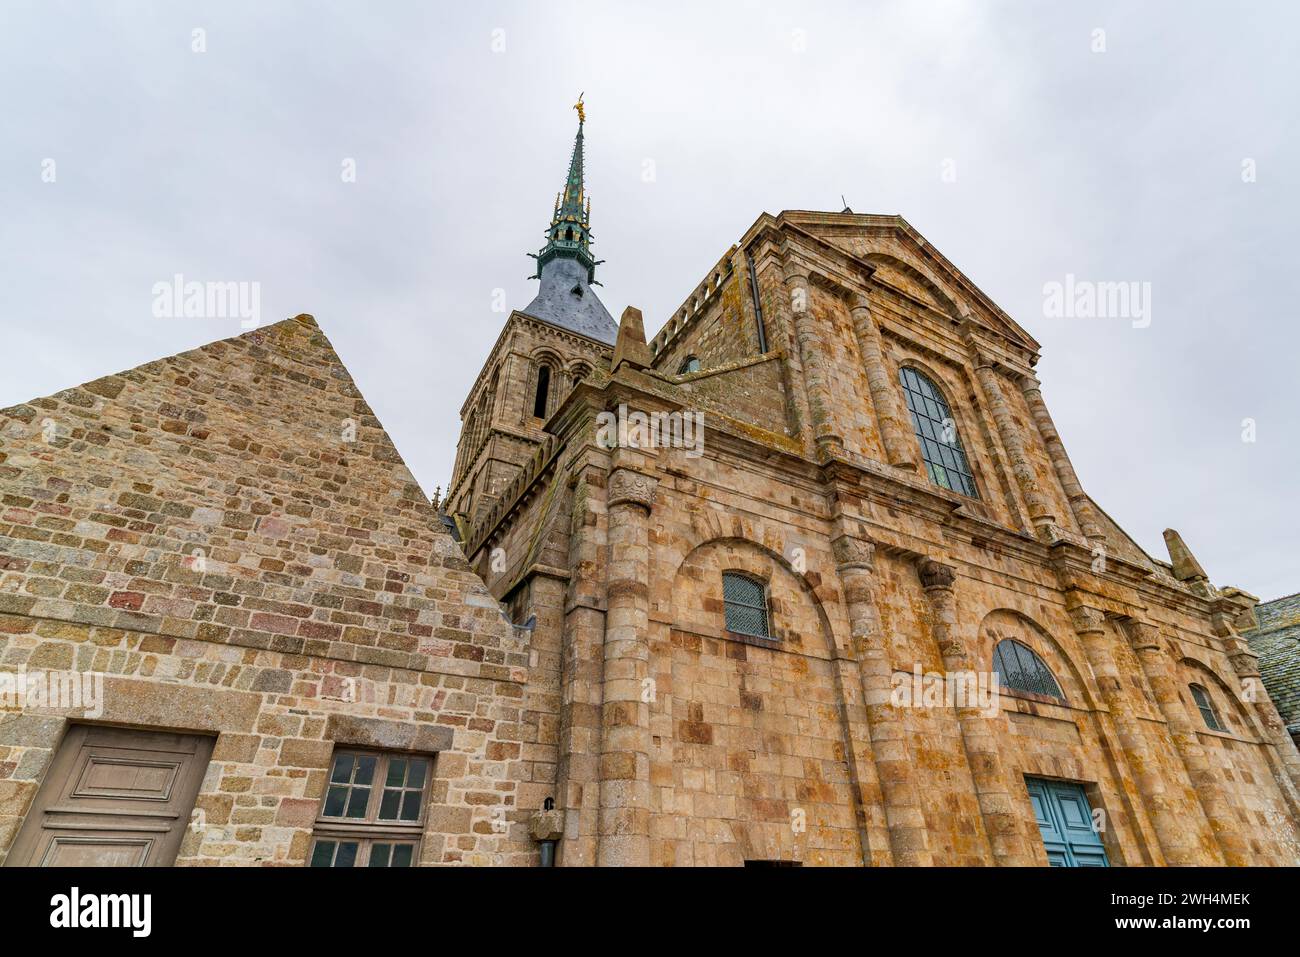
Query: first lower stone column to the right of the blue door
1070 605 1205 866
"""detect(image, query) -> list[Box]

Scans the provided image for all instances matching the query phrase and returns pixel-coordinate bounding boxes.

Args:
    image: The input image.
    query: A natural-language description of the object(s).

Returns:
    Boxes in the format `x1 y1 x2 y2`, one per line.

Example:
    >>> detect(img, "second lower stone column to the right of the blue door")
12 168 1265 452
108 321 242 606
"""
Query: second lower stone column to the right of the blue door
1126 620 1251 867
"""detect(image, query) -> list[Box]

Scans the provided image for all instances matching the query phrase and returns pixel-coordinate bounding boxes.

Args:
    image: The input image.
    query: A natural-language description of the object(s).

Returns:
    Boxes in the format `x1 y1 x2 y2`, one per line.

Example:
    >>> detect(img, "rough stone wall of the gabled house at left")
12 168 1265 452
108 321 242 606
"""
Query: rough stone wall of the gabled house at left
0 316 538 865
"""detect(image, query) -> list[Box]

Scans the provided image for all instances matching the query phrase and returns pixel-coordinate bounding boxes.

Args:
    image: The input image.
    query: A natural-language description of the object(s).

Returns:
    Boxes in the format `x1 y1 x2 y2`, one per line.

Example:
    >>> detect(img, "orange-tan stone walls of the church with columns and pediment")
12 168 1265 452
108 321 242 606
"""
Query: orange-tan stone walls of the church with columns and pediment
447 211 1300 865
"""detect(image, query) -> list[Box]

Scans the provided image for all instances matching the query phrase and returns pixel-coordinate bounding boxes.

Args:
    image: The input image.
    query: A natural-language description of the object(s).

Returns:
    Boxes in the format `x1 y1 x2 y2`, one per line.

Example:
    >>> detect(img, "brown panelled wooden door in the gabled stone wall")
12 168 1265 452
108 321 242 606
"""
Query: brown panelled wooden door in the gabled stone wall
7 724 212 867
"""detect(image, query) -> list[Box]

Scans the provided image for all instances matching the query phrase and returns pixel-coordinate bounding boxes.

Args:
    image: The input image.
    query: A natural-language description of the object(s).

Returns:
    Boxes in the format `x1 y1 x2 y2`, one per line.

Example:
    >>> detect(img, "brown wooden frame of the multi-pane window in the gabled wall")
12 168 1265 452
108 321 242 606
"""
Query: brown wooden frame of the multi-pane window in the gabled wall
307 748 436 867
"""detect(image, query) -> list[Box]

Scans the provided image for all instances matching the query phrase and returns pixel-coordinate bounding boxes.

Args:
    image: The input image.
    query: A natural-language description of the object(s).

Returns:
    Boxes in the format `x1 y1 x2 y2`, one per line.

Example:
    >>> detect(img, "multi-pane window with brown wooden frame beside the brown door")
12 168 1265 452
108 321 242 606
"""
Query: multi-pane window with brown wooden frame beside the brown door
308 750 433 867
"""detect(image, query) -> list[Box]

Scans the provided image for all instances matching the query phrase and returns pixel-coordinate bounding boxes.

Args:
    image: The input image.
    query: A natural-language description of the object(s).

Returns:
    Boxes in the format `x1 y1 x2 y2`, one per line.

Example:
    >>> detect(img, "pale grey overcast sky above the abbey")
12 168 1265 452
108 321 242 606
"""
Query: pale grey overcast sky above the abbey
0 0 1300 599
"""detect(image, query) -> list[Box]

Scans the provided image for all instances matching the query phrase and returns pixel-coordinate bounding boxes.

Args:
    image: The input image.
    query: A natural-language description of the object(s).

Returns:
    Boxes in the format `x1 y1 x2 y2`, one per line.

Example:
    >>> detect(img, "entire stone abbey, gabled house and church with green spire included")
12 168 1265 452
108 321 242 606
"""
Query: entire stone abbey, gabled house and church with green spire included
0 111 1300 866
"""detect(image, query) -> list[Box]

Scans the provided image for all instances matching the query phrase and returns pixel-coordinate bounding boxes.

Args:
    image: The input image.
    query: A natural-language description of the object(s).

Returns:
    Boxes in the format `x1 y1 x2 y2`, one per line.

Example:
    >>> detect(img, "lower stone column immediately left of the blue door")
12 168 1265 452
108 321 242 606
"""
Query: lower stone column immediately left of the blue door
918 559 1035 867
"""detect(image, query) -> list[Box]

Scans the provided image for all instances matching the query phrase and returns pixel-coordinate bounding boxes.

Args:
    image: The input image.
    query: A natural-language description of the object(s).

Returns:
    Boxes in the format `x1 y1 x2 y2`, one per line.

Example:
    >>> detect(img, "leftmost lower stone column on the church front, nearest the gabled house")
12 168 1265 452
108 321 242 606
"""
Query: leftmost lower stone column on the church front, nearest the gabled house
555 465 606 867
